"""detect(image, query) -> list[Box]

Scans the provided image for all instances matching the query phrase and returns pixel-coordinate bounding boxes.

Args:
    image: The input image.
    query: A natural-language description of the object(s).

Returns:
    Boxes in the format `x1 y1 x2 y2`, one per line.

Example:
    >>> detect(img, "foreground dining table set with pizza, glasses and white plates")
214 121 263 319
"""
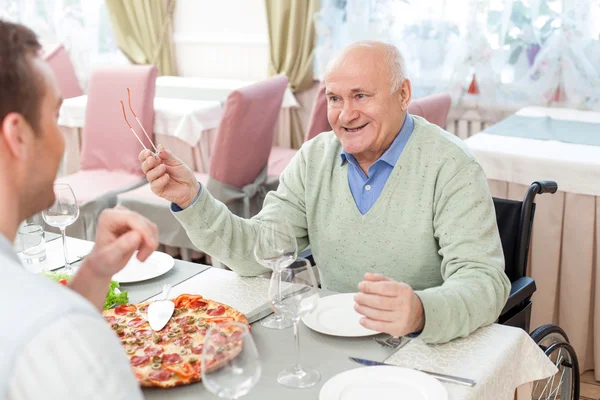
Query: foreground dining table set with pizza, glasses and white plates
31 234 556 400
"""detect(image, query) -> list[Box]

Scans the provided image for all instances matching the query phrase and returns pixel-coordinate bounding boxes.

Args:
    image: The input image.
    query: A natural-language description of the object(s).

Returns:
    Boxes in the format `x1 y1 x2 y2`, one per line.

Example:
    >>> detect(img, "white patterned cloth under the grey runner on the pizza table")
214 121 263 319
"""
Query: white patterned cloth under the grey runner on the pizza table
150 268 556 400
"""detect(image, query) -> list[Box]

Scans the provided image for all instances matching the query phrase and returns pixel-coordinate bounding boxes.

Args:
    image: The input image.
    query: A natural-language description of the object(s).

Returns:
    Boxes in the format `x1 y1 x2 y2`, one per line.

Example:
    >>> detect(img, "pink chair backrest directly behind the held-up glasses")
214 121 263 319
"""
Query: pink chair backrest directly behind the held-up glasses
81 65 158 175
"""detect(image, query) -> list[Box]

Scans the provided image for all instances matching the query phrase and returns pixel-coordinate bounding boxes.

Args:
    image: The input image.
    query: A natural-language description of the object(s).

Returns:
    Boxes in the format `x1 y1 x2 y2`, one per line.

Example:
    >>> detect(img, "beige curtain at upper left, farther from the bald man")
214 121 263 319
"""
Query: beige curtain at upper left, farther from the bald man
106 0 177 75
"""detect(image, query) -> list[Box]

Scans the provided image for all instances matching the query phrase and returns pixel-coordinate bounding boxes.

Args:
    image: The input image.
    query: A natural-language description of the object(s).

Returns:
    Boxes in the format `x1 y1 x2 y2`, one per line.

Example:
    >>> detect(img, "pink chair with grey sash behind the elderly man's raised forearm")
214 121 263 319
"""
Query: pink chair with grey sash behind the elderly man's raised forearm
117 75 288 253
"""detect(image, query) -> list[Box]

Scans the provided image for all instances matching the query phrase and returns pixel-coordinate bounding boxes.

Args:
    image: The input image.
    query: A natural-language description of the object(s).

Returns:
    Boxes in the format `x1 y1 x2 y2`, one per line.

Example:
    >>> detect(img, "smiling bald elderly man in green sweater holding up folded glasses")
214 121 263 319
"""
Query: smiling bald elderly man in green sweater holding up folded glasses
140 42 510 342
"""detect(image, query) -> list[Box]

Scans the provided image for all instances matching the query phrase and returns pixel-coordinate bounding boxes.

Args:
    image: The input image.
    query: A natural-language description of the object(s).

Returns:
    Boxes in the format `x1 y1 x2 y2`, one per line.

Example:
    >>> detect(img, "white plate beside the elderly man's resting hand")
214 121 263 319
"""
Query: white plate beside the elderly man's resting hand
302 293 379 337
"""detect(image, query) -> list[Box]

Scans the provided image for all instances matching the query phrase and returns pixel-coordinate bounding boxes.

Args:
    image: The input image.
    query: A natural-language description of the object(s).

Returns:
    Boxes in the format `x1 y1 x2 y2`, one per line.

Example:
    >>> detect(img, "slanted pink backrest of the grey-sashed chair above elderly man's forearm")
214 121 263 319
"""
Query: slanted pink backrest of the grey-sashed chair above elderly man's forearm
209 75 288 188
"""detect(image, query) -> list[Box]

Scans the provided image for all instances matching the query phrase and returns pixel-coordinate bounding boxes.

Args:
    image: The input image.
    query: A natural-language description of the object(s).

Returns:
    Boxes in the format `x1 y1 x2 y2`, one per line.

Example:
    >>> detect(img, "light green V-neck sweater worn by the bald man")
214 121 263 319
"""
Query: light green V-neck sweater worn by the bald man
175 116 510 343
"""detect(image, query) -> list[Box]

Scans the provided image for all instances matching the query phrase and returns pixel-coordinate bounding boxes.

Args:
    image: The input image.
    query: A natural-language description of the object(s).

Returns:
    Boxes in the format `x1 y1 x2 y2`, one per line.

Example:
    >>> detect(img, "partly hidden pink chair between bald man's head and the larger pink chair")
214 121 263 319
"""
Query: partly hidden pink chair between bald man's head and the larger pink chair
268 81 331 177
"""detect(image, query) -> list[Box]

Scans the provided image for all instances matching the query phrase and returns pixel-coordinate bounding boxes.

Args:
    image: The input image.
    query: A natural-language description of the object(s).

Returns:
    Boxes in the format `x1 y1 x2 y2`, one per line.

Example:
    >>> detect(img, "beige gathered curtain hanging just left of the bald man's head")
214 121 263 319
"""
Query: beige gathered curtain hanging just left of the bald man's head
265 0 320 149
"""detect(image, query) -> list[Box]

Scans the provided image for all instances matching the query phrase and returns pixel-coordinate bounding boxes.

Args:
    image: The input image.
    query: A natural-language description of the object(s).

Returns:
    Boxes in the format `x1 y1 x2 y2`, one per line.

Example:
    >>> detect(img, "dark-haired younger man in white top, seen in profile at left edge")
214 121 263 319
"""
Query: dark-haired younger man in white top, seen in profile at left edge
0 20 158 400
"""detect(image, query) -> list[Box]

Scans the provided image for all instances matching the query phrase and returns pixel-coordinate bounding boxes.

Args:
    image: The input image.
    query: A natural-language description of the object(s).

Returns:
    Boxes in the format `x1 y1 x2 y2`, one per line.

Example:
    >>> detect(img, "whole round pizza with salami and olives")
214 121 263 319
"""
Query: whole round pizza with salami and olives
102 294 250 388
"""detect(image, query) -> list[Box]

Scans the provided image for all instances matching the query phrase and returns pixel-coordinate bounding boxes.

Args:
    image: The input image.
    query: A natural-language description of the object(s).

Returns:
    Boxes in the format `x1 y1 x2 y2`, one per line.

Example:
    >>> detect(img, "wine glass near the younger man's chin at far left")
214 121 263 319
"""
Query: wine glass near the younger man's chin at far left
42 183 79 274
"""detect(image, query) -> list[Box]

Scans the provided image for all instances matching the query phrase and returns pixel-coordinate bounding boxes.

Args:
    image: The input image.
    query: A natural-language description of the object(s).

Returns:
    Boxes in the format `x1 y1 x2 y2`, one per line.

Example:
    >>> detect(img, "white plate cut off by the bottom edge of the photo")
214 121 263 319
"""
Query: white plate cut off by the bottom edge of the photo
319 365 448 400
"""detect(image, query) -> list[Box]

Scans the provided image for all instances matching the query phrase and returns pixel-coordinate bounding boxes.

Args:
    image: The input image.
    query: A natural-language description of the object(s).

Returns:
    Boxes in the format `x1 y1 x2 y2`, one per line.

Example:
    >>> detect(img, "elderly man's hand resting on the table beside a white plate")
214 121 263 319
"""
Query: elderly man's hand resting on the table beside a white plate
354 273 425 336
